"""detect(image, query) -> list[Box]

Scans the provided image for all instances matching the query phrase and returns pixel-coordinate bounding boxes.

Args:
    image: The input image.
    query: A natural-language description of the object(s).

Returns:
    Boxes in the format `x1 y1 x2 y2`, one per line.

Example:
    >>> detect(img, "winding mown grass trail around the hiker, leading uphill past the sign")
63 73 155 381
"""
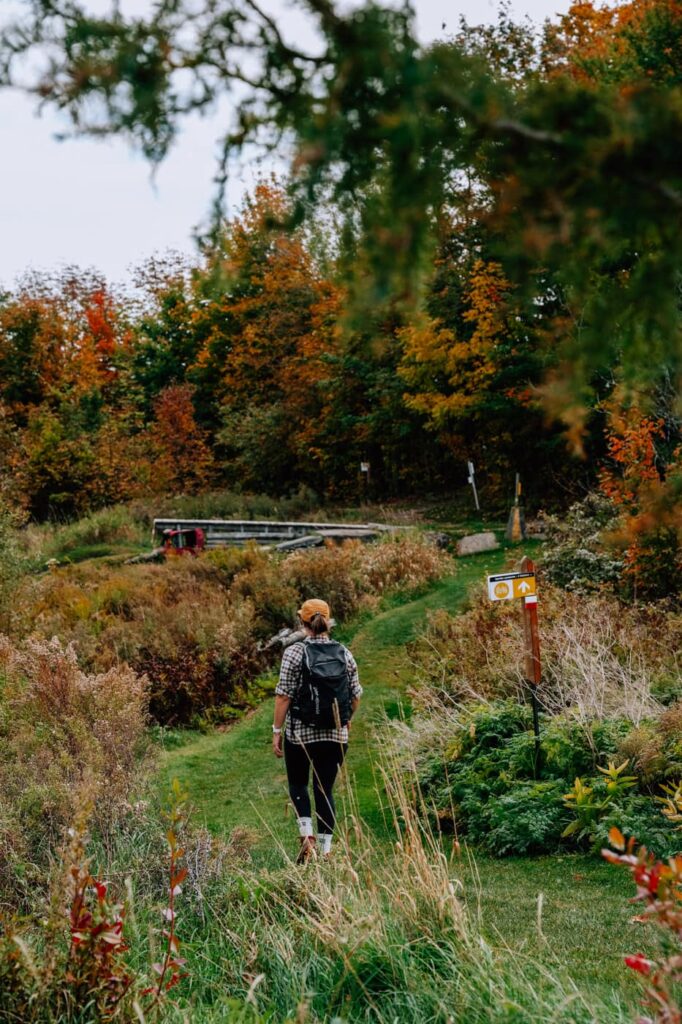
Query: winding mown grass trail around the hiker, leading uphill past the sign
161 551 504 851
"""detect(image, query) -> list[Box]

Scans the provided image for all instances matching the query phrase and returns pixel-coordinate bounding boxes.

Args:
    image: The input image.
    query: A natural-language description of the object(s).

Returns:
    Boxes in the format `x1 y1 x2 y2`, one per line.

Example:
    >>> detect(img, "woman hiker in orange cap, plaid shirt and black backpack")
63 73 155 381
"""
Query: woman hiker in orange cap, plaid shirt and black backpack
272 599 363 864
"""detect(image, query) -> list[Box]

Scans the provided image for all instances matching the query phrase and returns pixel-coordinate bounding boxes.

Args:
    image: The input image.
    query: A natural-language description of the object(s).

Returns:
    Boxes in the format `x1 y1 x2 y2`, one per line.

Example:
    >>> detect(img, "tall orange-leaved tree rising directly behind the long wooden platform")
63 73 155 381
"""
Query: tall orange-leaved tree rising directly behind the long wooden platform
187 182 339 492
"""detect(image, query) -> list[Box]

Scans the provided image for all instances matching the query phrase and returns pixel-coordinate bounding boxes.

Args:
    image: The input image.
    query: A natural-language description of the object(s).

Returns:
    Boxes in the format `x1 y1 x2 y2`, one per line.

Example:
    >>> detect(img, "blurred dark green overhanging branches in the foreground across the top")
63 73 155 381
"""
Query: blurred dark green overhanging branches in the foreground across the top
5 0 680 423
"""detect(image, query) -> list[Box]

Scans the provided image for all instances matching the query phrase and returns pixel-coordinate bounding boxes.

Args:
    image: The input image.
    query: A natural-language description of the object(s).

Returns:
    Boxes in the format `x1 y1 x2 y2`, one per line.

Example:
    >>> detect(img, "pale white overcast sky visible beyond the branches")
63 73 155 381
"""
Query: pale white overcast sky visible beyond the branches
0 0 568 286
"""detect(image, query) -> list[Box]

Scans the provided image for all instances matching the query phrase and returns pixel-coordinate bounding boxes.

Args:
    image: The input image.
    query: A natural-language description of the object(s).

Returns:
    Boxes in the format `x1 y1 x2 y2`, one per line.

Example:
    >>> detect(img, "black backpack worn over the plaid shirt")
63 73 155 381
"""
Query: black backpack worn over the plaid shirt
292 640 350 729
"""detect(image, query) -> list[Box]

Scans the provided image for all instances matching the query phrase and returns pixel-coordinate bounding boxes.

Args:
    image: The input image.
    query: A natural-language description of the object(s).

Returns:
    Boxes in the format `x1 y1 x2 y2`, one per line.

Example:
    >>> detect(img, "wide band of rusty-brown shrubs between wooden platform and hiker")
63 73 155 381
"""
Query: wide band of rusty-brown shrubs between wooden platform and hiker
17 538 452 724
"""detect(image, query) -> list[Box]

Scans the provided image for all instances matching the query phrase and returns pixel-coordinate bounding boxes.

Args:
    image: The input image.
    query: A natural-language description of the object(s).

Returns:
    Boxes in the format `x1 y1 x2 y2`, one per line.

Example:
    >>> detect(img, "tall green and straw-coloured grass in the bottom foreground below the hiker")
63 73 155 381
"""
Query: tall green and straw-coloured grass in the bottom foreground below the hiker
142 761 629 1024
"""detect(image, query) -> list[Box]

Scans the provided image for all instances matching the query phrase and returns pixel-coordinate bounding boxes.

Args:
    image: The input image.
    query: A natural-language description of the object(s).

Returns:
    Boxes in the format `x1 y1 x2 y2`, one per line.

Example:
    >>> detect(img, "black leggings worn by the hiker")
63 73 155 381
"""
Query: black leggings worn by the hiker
285 740 348 835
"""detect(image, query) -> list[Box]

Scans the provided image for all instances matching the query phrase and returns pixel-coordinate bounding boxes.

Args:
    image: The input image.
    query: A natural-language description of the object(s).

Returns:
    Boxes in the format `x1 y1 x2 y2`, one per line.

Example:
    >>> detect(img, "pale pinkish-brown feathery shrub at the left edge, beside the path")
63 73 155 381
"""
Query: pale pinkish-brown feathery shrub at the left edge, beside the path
0 639 147 902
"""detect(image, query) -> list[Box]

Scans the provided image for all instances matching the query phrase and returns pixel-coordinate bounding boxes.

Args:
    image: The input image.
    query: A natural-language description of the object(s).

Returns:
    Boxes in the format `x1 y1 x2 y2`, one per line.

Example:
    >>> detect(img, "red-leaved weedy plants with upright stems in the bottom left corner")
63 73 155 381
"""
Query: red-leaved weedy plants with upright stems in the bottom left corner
0 781 193 1024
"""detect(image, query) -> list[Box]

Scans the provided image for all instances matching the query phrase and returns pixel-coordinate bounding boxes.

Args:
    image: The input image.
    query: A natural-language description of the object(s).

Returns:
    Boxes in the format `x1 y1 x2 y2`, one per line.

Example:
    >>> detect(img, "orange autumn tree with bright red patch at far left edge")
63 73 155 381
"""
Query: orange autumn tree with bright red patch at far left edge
0 269 148 518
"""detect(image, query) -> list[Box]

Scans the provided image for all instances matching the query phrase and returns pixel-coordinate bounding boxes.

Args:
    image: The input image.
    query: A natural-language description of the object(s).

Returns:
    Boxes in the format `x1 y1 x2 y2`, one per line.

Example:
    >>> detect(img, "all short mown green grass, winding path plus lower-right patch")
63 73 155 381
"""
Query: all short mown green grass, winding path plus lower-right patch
156 552 643 997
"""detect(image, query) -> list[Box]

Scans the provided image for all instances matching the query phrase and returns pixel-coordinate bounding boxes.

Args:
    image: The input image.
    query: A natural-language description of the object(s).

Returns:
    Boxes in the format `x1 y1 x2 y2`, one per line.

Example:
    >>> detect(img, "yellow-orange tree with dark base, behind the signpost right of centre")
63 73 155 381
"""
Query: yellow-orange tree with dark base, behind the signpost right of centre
399 223 590 502
